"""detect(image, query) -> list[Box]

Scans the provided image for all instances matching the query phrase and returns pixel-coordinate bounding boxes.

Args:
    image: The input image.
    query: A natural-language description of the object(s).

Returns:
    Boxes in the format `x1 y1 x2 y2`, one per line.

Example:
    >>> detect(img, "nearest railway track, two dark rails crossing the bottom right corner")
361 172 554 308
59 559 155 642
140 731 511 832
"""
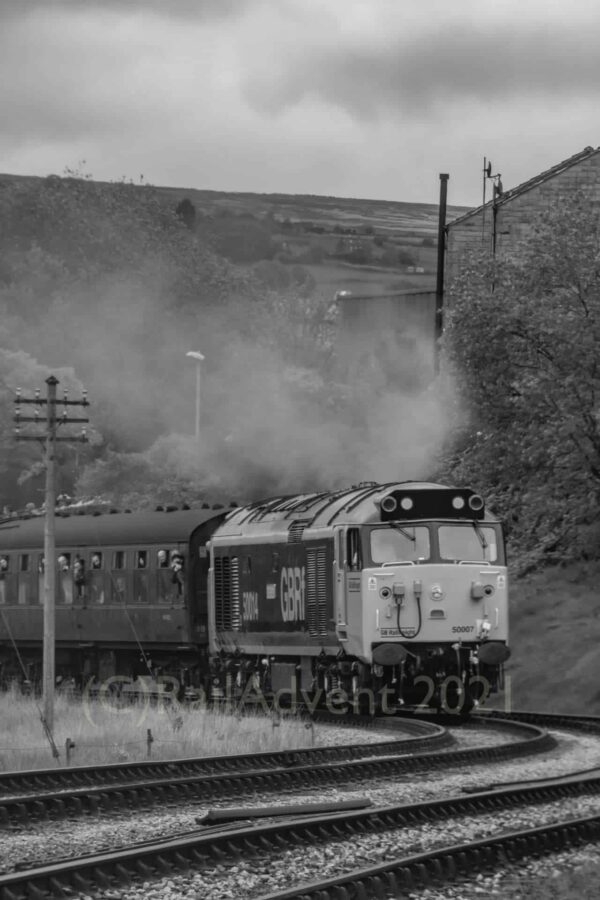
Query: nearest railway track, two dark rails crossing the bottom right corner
0 770 600 900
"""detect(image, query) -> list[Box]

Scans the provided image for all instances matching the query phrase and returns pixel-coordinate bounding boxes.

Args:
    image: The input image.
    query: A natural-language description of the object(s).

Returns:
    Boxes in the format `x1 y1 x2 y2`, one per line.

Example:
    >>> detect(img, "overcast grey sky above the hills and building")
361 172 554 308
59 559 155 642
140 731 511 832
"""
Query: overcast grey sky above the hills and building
0 0 600 205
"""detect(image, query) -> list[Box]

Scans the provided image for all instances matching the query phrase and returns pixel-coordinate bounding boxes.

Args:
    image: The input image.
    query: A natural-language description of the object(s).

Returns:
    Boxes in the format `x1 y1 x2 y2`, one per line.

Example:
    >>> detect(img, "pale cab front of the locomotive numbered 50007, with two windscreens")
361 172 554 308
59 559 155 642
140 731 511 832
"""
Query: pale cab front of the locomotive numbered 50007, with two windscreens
337 484 510 712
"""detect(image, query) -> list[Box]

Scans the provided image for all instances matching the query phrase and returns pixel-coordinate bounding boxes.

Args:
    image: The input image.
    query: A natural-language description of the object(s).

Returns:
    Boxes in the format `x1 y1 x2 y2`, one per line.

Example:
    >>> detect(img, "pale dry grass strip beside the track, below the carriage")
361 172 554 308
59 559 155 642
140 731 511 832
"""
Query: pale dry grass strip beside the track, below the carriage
0 691 313 771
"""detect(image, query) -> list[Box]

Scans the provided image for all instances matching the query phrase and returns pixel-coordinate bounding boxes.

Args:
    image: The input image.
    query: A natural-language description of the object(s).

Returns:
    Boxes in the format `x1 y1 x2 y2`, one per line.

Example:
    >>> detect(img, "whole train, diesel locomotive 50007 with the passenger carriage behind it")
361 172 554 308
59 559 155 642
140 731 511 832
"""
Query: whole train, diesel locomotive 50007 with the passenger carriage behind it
0 482 510 711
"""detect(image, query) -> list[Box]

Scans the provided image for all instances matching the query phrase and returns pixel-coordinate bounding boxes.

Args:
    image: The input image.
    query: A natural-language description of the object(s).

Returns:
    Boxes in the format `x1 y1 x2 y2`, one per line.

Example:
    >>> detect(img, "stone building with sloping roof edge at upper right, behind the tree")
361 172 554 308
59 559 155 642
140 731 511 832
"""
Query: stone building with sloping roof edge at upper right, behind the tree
445 147 600 287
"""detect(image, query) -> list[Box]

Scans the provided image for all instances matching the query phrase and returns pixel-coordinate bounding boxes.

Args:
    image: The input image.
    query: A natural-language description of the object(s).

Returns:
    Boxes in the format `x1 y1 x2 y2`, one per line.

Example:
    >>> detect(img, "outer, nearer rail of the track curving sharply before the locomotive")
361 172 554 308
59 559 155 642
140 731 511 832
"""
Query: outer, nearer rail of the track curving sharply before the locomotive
0 720 555 826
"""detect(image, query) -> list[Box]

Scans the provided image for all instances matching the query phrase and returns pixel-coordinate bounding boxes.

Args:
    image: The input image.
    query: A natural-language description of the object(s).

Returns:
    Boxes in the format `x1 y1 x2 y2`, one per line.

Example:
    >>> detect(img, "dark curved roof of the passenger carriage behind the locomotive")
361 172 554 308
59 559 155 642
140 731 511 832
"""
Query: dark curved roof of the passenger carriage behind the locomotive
0 509 227 552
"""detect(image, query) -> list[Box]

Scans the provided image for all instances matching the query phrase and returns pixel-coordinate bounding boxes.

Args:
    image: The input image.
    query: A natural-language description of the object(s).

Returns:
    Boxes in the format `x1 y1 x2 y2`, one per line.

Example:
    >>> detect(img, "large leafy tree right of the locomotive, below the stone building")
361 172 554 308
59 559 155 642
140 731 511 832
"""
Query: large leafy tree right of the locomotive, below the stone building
444 195 600 564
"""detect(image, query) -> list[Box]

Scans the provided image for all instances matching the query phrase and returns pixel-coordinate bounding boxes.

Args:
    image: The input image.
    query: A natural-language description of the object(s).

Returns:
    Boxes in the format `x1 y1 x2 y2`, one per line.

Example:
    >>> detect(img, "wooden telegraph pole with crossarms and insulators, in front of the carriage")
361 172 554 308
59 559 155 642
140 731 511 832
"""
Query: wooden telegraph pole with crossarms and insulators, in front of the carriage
14 375 89 736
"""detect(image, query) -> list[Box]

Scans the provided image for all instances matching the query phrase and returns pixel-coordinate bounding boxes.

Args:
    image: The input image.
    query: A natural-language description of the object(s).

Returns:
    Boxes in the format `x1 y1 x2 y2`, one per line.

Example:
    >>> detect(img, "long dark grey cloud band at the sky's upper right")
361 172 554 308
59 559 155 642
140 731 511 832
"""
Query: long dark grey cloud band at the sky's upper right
245 19 600 120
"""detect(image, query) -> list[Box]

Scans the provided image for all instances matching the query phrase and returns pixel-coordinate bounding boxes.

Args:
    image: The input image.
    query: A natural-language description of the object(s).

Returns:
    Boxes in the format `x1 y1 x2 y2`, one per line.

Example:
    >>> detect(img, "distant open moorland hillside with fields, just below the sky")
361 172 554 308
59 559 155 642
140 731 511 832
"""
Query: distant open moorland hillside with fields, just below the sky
0 174 468 296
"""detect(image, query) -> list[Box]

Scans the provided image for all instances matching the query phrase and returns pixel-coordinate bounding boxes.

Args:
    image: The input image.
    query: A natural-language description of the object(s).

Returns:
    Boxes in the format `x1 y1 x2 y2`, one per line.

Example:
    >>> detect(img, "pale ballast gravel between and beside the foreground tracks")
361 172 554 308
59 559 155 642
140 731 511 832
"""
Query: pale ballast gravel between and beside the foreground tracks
0 726 600 900
